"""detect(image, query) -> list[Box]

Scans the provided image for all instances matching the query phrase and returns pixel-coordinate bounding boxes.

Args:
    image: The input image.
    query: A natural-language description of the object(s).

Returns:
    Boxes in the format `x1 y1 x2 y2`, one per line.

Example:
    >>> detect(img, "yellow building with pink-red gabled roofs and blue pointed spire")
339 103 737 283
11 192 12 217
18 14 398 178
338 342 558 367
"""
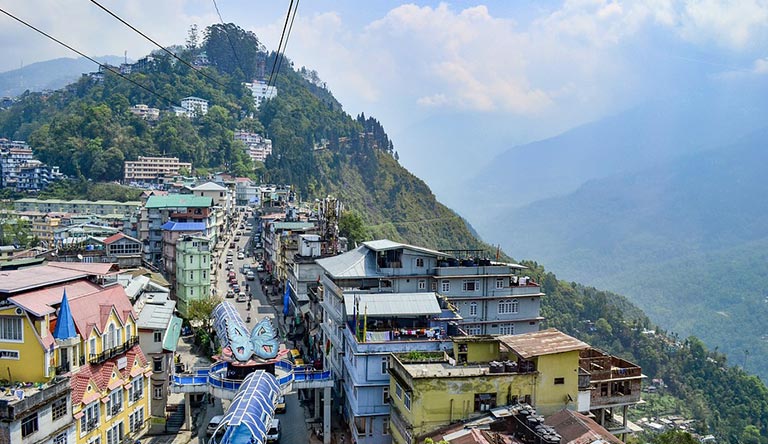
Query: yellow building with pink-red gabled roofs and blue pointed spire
0 267 152 444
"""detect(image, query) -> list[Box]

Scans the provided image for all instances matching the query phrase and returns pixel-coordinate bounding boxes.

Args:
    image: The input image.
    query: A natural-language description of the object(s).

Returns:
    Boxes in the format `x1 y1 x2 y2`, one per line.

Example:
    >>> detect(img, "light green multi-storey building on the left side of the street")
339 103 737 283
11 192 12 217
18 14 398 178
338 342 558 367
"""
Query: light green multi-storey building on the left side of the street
176 236 212 317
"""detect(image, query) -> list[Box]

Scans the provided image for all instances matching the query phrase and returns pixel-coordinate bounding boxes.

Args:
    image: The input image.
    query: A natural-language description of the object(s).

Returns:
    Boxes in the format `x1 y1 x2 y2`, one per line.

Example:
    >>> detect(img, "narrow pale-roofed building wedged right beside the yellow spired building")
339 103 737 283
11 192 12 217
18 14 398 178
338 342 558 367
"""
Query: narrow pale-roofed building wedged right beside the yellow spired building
133 289 181 433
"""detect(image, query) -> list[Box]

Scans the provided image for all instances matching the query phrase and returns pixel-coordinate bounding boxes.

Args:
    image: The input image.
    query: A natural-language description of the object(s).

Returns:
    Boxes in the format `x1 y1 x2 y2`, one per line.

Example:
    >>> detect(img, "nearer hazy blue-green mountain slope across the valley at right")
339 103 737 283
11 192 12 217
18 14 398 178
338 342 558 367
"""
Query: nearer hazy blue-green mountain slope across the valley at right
497 129 768 377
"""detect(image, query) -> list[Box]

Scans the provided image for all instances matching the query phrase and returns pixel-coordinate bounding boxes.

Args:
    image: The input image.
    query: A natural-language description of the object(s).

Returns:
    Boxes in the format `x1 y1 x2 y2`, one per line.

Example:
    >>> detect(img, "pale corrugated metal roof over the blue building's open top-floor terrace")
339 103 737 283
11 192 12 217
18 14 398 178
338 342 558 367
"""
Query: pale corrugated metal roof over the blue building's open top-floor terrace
344 292 442 316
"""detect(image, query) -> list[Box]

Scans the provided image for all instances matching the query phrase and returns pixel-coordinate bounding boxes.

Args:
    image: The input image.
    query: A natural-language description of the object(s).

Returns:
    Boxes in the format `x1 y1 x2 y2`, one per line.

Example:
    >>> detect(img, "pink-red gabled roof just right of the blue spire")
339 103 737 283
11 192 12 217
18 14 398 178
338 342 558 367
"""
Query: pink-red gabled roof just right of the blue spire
69 285 136 338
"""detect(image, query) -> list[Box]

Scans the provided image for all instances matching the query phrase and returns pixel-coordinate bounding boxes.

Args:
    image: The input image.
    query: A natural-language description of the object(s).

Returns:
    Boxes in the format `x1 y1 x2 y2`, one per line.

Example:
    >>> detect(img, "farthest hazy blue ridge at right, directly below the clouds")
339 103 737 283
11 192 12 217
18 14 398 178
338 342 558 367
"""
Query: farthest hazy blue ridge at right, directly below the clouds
450 92 768 229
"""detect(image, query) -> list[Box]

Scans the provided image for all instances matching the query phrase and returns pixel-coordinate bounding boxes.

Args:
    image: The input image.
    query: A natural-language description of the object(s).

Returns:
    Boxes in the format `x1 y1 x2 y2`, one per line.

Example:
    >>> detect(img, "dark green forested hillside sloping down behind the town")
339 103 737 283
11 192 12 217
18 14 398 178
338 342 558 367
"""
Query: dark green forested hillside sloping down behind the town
0 25 768 443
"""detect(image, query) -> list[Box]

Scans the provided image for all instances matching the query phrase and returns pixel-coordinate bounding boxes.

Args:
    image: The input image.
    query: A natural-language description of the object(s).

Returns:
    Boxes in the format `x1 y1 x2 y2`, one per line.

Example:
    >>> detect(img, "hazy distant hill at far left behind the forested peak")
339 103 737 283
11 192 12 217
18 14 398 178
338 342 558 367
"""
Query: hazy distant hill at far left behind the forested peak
0 56 126 97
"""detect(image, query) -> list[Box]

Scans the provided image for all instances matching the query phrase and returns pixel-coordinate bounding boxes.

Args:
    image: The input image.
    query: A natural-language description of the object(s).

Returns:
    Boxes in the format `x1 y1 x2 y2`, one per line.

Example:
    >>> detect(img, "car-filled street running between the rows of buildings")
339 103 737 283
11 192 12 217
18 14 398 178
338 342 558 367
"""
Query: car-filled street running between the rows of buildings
212 210 310 444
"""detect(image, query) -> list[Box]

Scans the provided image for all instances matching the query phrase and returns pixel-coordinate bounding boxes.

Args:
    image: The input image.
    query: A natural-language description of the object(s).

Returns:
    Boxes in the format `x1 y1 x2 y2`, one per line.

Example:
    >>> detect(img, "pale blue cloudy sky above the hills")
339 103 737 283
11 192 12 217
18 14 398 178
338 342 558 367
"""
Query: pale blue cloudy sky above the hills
0 0 768 196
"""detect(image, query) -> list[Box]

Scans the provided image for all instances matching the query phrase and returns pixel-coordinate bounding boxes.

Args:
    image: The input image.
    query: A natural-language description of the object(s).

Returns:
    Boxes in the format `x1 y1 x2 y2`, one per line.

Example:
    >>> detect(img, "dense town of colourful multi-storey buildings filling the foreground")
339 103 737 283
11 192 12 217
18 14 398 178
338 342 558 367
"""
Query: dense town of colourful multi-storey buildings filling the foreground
0 162 712 444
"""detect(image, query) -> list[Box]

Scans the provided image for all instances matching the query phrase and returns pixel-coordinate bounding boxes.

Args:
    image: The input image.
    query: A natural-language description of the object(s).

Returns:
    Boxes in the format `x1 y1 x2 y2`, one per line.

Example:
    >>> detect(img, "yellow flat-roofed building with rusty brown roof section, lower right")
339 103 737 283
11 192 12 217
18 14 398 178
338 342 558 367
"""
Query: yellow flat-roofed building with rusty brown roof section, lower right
389 329 589 444
